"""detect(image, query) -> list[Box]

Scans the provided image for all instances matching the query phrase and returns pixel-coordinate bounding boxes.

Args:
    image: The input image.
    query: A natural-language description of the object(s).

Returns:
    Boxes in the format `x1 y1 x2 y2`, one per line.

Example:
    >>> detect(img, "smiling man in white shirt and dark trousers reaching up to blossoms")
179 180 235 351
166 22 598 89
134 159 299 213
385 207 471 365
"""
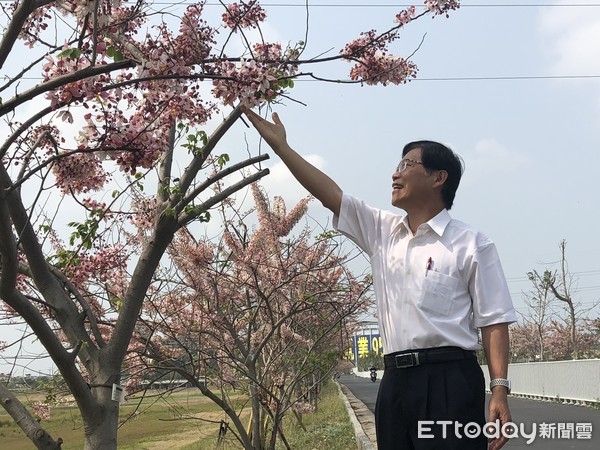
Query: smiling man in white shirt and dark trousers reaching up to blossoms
244 110 516 450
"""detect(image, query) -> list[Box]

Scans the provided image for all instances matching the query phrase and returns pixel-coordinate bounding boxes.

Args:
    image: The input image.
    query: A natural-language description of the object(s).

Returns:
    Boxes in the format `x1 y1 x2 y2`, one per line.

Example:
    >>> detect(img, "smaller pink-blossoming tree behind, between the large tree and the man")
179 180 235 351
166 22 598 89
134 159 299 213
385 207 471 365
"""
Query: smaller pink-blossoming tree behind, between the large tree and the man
128 185 372 450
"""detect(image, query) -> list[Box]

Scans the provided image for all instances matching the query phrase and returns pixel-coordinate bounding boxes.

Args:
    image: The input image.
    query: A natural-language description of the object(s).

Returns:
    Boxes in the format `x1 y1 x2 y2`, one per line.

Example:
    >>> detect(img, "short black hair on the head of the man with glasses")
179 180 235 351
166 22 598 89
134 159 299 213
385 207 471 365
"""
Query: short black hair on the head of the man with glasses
402 141 464 209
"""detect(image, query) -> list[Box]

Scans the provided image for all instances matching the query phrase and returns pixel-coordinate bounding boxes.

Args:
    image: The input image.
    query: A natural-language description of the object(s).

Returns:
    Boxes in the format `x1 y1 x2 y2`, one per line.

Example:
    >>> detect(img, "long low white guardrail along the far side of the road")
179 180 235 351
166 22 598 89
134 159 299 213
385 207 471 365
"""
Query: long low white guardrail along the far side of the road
354 359 600 404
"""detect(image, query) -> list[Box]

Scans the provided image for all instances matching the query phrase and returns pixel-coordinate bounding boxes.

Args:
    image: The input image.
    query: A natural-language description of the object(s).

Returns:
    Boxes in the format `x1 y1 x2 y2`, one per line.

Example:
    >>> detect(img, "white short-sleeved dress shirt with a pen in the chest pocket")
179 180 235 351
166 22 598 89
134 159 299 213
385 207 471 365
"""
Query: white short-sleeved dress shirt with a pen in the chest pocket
333 194 517 354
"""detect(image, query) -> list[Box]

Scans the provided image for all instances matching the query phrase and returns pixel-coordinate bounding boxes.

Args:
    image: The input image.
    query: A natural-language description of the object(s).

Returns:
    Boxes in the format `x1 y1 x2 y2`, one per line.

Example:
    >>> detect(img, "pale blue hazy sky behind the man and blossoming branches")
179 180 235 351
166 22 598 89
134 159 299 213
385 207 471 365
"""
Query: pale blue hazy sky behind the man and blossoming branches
0 0 600 371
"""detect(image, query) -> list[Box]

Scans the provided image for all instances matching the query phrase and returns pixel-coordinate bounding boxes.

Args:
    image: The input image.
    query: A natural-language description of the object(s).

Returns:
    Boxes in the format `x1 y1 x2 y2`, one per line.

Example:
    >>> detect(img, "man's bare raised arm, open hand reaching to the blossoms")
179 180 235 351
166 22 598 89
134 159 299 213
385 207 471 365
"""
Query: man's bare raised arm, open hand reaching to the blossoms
244 109 342 215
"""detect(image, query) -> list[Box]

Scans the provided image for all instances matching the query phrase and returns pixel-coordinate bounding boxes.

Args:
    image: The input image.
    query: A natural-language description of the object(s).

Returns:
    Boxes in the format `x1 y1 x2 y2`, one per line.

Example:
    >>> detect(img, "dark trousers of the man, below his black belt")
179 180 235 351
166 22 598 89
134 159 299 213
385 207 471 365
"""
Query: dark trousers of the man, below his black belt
375 352 487 450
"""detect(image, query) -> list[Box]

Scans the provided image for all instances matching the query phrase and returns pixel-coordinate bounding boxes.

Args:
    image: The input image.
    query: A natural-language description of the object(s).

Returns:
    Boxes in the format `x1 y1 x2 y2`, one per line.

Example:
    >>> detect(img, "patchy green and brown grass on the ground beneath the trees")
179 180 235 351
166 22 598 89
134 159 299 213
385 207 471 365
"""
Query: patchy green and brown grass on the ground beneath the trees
0 383 356 450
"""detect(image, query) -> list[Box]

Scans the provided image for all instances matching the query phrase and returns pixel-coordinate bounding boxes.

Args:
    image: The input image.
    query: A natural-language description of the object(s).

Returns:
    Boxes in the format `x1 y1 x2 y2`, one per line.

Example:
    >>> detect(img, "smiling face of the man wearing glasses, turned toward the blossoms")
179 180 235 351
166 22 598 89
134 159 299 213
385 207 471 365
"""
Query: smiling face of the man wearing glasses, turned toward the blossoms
392 148 435 212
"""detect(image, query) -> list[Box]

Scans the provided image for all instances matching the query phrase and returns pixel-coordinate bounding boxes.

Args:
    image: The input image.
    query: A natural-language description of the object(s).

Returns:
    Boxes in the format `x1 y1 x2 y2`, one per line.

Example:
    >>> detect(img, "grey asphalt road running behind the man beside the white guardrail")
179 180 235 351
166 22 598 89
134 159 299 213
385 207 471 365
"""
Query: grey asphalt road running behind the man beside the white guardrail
338 375 600 450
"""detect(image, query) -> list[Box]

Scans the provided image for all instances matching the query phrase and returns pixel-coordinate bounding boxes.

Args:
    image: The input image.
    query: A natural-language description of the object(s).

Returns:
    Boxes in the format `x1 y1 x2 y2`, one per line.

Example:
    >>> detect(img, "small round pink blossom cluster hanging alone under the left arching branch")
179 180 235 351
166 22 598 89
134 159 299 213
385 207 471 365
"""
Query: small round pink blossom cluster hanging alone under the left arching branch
52 153 110 193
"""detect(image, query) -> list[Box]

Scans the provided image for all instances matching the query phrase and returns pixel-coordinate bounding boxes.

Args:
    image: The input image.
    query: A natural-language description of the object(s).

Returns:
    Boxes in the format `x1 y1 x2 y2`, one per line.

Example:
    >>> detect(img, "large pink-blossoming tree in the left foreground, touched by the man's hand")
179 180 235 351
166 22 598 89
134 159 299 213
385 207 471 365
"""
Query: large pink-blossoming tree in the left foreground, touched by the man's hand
0 0 458 449
